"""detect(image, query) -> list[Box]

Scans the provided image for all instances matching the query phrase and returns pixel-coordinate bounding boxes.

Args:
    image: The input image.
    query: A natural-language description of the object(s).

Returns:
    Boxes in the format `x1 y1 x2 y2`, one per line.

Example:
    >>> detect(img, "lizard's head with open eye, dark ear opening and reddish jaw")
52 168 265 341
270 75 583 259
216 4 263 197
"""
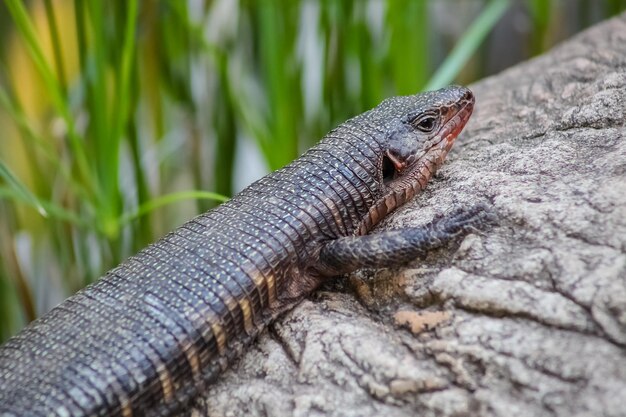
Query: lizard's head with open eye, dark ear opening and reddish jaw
357 86 474 234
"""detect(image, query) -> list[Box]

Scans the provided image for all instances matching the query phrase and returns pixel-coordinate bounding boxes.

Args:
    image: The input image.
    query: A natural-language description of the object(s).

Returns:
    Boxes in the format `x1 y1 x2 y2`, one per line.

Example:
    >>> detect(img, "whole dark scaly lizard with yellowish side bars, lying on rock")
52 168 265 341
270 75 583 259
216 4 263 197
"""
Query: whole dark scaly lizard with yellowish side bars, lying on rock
0 86 484 417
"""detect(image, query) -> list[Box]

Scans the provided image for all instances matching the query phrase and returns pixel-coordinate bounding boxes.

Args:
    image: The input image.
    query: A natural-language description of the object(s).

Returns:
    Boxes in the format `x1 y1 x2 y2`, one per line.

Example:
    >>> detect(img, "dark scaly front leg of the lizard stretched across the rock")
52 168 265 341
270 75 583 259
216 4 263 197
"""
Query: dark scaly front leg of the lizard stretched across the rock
318 206 493 276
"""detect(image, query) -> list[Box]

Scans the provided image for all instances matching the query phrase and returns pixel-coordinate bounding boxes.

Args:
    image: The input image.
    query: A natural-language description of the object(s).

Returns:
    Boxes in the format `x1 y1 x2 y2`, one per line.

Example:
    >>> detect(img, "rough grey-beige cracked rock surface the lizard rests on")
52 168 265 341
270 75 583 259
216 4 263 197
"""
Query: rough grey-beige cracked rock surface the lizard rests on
193 15 626 416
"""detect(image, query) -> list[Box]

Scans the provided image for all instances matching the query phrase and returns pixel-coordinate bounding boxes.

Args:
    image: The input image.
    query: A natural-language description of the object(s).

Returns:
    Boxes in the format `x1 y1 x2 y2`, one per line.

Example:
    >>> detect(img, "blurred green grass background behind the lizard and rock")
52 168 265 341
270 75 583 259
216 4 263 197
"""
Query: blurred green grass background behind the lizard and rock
0 0 626 341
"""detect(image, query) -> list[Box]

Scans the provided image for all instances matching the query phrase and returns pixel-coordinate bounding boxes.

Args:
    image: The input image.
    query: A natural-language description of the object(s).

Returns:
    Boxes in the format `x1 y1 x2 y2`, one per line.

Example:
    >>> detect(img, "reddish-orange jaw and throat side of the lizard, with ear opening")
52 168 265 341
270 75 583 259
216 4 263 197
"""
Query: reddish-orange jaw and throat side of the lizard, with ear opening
355 98 474 235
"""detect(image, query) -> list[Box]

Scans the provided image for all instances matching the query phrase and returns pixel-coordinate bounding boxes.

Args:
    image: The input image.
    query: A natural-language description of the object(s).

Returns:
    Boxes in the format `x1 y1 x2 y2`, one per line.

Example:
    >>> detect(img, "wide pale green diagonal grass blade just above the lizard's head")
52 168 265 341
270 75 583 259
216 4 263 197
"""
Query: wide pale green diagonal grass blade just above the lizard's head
424 0 511 90
